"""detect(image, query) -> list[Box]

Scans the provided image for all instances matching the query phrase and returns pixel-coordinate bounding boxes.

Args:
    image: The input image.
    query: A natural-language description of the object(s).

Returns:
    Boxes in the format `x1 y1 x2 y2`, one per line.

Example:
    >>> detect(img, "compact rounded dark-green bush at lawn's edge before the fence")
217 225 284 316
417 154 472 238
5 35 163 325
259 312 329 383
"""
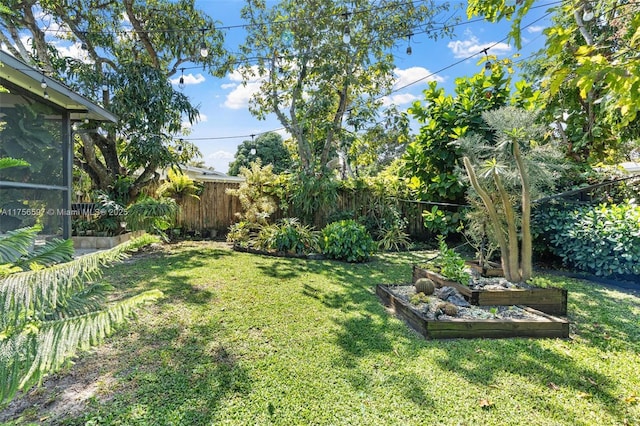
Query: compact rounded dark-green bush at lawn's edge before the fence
322 220 376 262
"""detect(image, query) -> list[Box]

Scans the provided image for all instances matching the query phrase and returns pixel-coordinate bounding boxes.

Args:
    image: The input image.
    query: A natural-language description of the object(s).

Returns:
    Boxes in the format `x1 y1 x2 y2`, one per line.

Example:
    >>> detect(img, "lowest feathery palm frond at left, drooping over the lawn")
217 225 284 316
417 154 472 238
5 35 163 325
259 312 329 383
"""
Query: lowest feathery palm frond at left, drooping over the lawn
0 290 162 403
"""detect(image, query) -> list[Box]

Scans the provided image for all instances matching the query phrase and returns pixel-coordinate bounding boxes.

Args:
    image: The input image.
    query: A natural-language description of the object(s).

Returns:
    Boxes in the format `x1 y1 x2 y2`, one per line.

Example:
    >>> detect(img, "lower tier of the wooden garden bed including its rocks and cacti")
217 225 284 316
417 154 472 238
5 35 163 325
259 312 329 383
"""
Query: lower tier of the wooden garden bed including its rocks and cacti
376 284 569 339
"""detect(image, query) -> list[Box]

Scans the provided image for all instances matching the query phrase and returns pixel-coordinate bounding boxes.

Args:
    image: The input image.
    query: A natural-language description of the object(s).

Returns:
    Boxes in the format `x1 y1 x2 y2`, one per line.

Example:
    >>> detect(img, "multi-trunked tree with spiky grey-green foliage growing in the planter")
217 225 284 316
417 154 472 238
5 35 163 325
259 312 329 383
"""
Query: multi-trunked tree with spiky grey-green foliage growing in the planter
459 106 557 282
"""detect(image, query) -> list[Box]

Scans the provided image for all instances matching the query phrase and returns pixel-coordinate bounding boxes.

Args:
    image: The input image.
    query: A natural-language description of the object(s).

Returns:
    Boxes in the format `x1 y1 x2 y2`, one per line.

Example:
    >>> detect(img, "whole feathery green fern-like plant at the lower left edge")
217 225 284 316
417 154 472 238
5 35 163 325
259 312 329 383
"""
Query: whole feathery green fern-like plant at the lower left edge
0 228 161 404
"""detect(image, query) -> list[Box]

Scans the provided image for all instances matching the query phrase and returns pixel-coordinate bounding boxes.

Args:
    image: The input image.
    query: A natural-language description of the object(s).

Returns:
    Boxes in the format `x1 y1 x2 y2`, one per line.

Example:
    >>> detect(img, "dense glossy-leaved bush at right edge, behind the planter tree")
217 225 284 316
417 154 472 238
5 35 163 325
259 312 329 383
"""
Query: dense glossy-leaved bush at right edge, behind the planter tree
533 202 640 276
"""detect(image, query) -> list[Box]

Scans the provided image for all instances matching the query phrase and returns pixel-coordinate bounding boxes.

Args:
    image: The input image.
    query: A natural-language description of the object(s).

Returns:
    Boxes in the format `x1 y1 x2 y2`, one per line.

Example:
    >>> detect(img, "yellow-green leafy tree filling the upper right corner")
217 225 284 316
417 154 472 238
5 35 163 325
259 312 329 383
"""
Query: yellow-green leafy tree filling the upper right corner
467 0 640 163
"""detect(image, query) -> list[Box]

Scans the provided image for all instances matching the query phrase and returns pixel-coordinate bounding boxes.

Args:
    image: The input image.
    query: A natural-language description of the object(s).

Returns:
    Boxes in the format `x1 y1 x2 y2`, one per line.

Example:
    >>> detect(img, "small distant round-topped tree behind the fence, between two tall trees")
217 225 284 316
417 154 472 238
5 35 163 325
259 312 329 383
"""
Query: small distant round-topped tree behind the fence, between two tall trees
229 132 291 176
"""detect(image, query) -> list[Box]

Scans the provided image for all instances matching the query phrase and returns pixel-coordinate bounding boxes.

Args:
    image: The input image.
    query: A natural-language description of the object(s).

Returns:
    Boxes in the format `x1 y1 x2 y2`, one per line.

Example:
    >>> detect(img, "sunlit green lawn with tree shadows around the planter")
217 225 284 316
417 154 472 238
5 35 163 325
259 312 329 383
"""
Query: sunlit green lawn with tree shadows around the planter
1 243 640 425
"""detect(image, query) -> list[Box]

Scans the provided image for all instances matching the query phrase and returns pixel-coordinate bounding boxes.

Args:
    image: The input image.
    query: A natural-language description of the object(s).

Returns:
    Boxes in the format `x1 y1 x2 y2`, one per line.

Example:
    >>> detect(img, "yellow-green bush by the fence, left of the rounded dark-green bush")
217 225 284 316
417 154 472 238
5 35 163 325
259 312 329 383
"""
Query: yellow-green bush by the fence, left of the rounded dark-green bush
255 218 319 254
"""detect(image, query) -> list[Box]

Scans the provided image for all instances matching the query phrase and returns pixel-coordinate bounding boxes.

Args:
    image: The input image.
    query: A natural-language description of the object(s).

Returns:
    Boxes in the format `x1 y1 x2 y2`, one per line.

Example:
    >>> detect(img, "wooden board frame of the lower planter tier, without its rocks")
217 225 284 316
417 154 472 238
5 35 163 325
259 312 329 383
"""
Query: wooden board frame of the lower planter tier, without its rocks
376 284 569 339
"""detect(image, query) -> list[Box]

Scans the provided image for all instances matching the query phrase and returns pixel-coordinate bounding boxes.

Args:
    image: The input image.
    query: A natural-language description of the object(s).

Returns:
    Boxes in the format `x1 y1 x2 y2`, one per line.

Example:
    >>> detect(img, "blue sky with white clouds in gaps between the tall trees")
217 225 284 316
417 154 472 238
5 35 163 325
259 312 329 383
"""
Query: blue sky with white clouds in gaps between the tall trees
174 0 548 172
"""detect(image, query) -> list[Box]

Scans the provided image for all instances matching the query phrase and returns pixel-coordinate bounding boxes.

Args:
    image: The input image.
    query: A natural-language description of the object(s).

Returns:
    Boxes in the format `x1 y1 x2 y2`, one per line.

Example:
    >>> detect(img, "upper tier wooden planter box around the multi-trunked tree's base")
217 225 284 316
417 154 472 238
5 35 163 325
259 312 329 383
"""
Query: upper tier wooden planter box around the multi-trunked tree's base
413 265 567 316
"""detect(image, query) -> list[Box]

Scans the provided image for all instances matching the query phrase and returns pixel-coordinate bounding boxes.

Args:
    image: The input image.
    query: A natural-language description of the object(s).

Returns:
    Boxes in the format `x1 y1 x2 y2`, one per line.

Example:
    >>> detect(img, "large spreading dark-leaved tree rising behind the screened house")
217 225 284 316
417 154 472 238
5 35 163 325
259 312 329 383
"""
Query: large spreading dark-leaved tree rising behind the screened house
0 0 228 200
